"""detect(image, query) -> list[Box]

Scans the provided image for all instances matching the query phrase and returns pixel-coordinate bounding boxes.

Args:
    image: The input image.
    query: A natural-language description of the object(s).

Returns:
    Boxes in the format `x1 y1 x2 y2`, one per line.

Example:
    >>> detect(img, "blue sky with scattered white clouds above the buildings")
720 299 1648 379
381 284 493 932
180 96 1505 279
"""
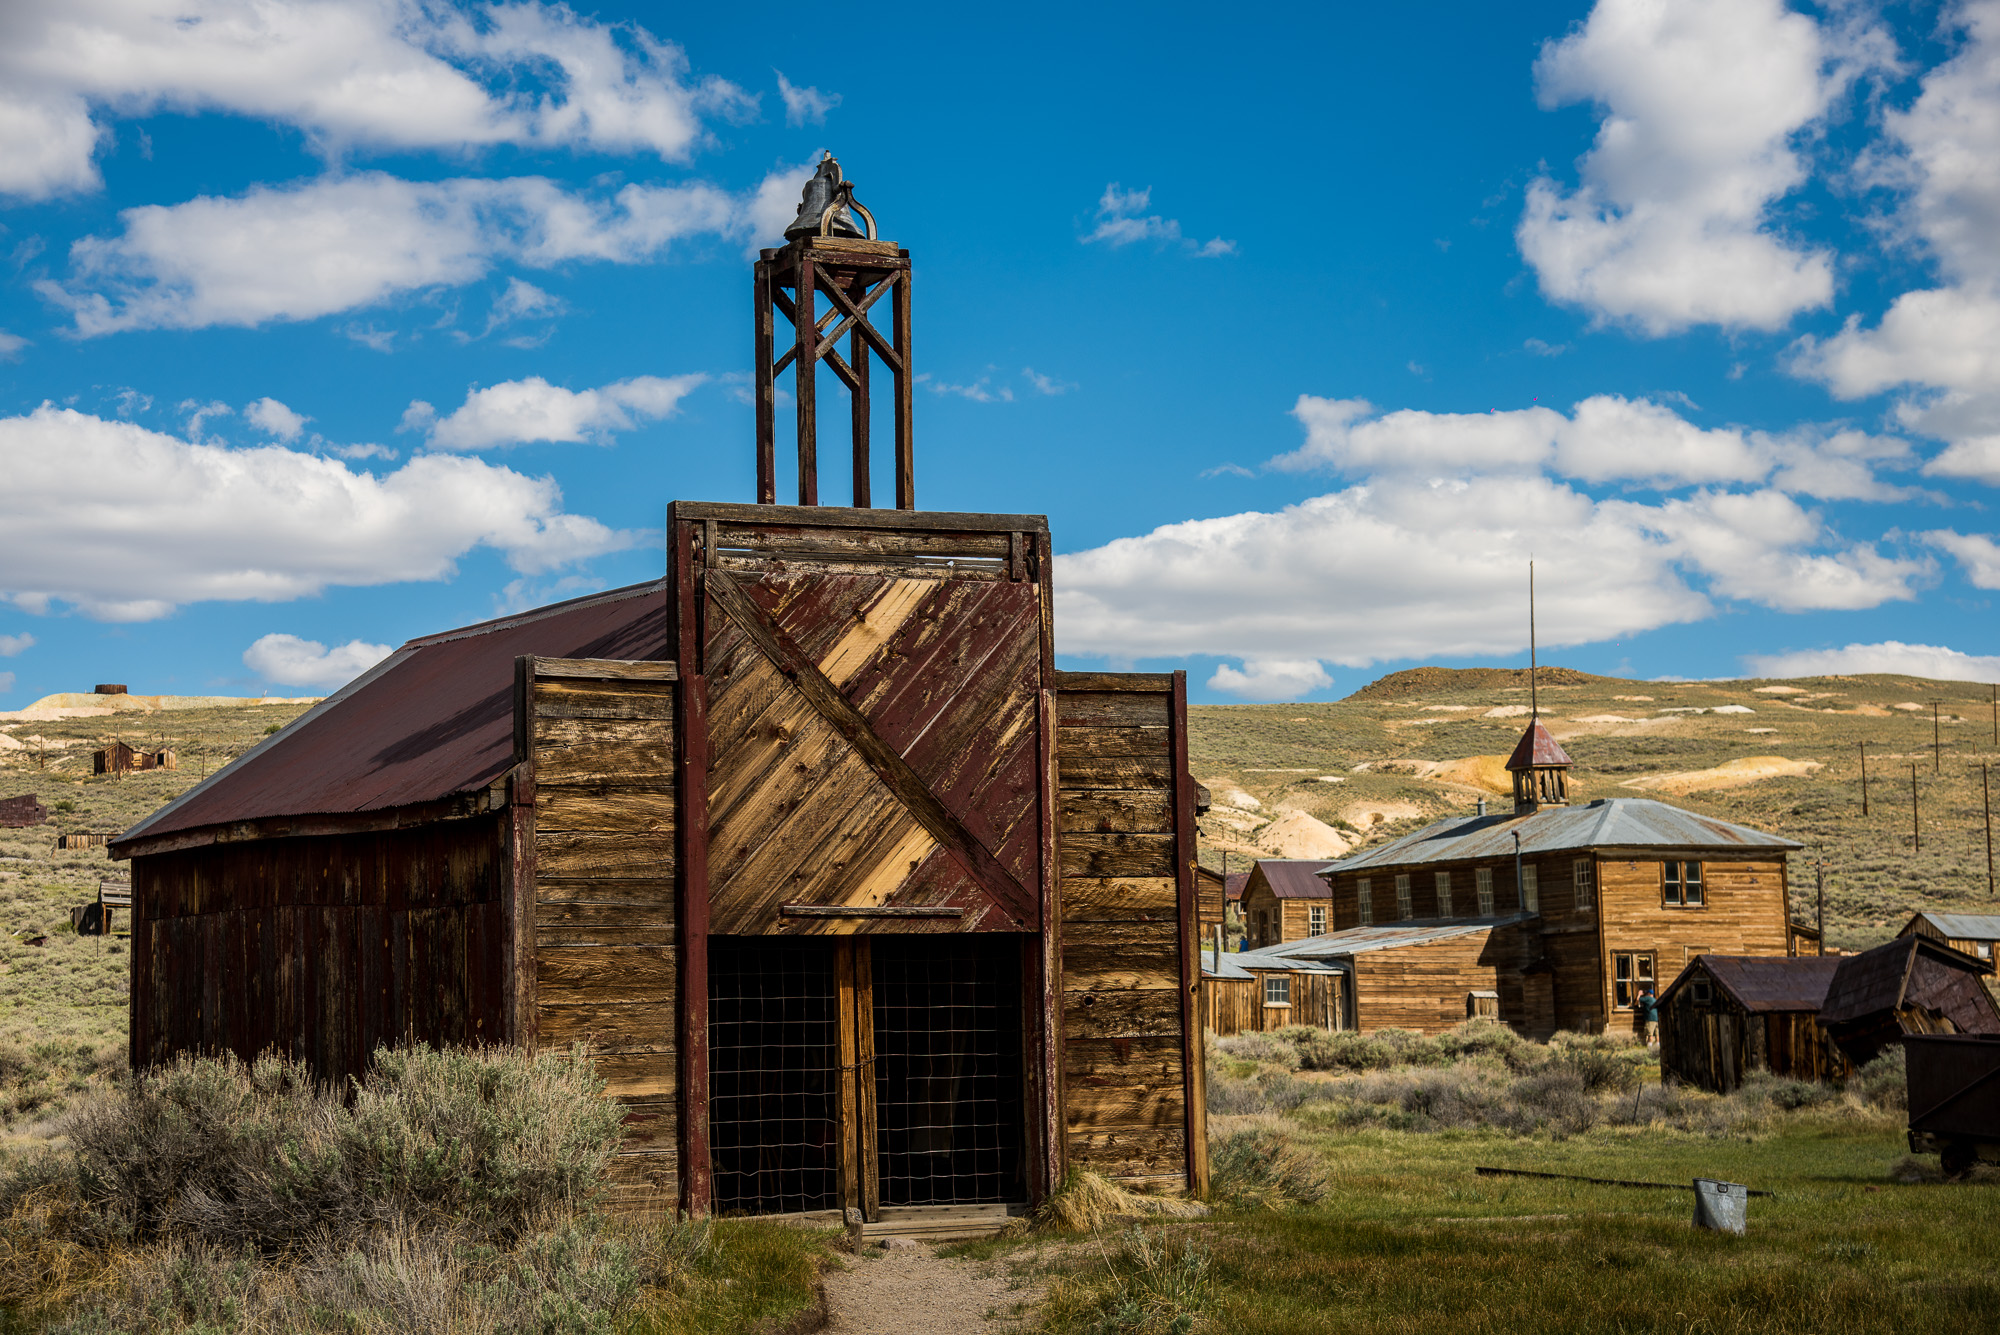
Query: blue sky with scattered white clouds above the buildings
0 0 2000 709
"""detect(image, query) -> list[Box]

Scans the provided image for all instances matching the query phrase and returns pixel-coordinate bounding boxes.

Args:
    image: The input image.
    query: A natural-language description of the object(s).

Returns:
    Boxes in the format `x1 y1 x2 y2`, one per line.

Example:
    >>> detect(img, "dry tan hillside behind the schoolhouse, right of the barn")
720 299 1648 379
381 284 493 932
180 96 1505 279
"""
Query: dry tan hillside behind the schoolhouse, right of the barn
1190 668 2000 947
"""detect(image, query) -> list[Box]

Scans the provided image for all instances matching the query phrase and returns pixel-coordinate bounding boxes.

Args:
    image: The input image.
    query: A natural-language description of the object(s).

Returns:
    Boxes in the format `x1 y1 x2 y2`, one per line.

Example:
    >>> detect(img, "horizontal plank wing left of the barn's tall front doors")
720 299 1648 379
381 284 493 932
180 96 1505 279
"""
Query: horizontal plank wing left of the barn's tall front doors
520 658 680 1211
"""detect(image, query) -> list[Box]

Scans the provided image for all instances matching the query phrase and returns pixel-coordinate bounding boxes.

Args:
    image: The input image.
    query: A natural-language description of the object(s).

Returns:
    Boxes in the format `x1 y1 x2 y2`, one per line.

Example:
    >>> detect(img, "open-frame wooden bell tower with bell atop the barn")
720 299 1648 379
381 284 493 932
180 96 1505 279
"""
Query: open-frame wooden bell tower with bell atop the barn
754 154 916 510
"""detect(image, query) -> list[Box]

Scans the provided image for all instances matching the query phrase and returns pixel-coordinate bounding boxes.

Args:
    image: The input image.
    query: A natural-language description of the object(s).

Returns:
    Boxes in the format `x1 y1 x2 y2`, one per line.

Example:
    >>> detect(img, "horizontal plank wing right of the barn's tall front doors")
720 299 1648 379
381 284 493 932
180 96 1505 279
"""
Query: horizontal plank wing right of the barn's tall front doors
1056 673 1202 1191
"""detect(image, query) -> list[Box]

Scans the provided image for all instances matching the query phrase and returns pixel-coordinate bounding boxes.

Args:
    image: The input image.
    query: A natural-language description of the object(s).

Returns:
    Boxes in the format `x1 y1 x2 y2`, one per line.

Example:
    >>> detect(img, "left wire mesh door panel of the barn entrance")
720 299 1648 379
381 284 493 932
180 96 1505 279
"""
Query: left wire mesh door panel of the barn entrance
708 937 842 1215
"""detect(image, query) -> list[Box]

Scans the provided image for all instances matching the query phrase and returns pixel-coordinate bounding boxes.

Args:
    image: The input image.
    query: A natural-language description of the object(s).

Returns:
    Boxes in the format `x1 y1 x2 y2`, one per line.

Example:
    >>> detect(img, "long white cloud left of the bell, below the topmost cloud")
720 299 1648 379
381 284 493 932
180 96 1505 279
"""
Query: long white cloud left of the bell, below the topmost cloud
36 172 746 333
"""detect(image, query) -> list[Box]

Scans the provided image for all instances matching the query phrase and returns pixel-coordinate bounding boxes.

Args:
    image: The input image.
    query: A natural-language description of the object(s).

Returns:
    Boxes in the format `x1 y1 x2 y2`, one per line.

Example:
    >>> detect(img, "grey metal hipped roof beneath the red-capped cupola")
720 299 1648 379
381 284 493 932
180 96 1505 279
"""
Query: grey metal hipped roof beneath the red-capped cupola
1320 797 1806 875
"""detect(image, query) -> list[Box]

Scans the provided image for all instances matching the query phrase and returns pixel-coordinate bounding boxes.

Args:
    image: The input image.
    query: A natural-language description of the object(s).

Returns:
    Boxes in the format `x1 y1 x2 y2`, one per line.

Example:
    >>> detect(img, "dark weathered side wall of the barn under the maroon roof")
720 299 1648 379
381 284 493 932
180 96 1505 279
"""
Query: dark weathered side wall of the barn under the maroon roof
130 813 508 1079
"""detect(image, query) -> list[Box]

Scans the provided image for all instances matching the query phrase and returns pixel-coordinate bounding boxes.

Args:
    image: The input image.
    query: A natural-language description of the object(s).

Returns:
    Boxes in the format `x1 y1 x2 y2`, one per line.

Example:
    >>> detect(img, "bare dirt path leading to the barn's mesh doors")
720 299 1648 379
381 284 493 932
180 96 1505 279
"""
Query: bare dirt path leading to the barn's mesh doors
826 1243 1042 1335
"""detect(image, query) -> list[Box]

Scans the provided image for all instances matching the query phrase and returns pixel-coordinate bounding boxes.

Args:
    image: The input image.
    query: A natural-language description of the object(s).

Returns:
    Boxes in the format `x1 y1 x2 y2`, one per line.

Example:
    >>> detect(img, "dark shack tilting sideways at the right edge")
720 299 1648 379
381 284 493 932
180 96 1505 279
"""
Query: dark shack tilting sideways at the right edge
1820 935 2000 1065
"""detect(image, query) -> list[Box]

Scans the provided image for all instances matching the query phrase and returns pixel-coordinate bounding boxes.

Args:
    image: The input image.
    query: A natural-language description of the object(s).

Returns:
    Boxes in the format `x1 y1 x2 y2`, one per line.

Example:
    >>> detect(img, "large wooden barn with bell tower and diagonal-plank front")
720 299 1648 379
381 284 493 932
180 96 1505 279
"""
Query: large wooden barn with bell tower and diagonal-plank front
114 158 1206 1231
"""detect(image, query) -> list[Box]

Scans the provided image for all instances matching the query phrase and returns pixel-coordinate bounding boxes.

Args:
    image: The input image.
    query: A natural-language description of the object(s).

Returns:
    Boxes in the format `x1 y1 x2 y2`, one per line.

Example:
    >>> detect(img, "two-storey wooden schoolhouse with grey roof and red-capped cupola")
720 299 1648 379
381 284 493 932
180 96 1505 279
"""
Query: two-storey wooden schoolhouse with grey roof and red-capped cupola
1322 719 1802 1039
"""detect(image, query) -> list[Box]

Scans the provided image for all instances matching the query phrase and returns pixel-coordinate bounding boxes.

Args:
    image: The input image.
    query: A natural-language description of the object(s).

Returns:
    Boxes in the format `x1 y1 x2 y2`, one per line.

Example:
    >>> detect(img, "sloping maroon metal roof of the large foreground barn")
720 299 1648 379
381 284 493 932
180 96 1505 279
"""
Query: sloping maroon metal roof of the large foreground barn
118 580 668 843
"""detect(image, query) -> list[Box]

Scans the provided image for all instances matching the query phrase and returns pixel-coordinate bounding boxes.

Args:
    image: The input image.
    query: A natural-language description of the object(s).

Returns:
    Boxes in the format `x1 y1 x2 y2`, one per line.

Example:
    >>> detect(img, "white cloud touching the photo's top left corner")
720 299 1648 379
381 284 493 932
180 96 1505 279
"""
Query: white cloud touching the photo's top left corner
0 0 754 198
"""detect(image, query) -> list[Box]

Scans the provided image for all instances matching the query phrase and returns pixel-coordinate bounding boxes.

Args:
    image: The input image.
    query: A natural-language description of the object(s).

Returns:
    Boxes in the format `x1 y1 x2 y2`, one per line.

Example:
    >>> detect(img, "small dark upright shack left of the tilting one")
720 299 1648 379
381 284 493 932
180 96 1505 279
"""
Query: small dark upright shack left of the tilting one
1660 955 1854 1093
